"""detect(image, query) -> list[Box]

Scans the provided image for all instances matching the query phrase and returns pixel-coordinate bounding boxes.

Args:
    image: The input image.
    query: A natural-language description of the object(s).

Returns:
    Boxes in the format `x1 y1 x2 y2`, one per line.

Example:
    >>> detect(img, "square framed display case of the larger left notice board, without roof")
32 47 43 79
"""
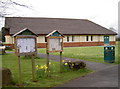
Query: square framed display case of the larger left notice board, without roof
15 36 37 56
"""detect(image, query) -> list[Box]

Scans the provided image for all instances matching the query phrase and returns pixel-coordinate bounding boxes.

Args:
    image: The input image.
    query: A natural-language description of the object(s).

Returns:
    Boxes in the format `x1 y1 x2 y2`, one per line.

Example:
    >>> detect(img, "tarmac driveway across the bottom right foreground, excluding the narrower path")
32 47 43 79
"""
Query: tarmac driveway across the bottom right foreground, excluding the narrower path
56 65 120 87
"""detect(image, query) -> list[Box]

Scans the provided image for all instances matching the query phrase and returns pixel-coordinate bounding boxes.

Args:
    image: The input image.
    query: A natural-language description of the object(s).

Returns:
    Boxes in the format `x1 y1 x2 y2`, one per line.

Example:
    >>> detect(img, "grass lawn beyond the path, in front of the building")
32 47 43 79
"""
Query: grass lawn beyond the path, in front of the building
38 42 120 64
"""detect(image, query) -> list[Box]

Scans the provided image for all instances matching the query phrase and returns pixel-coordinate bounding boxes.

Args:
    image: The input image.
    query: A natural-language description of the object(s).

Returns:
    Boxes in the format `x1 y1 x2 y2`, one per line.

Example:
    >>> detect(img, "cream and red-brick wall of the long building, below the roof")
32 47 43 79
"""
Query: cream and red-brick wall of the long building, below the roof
5 35 115 48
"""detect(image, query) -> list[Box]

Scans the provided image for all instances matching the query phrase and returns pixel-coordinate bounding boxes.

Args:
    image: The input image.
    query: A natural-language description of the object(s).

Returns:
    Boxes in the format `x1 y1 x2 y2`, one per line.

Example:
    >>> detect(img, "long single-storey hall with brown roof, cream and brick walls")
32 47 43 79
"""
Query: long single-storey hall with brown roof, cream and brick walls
4 17 117 48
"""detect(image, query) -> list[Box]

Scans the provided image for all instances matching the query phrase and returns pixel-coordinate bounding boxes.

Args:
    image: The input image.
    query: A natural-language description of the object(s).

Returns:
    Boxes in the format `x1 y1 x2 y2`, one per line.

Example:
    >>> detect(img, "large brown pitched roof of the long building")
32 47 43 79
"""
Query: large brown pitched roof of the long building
5 17 116 35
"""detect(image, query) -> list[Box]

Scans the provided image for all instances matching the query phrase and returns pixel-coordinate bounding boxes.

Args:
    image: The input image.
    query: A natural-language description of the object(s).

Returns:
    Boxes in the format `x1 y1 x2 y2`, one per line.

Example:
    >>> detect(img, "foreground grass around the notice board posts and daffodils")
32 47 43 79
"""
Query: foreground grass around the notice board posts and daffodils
2 54 92 87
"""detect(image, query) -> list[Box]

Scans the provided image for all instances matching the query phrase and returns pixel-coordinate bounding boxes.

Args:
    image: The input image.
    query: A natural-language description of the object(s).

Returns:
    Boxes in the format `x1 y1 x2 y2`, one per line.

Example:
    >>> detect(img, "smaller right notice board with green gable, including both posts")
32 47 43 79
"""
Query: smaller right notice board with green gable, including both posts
46 30 64 72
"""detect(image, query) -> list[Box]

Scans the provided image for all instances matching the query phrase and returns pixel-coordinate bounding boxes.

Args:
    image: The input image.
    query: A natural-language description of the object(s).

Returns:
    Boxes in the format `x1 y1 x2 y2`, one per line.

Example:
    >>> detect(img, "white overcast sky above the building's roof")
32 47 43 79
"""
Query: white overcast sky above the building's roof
0 0 120 29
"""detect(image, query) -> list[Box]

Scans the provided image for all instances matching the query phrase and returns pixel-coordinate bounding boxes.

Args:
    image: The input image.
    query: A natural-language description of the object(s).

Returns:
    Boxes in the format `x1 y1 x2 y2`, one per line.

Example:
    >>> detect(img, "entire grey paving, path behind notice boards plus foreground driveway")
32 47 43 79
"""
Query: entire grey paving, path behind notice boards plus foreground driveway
38 53 120 89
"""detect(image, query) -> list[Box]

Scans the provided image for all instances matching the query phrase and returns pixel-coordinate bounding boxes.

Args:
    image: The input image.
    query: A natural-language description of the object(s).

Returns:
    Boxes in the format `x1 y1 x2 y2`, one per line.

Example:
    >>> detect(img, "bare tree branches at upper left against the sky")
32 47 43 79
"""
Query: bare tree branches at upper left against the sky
0 0 32 42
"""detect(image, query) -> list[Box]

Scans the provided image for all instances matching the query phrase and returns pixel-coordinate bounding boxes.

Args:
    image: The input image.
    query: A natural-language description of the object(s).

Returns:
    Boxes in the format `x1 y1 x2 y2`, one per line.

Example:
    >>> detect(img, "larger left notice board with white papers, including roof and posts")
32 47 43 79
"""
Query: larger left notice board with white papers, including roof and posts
13 28 37 84
